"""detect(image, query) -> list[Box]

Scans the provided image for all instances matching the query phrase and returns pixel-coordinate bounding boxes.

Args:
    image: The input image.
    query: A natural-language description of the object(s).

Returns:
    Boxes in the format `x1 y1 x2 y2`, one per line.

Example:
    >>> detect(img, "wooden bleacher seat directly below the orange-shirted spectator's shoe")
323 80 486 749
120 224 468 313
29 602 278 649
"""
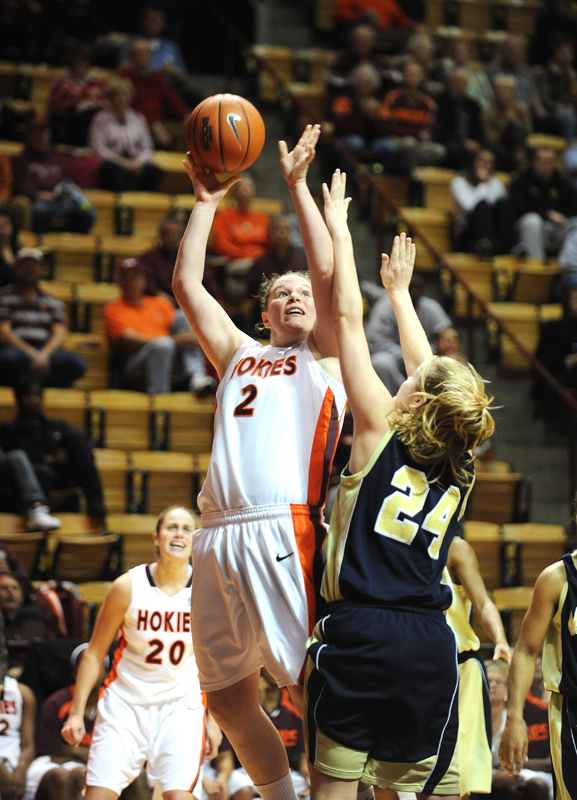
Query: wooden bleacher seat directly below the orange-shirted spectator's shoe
151 392 214 453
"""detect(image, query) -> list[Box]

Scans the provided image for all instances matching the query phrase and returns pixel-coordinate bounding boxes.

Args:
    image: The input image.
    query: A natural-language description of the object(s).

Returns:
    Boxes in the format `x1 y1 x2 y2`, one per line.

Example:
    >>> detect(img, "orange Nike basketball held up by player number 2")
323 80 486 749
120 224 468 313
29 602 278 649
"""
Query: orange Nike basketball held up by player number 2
186 94 265 173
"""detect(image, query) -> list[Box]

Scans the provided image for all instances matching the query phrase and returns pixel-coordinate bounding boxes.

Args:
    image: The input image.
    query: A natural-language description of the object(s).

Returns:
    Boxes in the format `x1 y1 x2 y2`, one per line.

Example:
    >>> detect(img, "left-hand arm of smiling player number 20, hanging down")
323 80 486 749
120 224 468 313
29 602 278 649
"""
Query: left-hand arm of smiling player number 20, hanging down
62 573 132 745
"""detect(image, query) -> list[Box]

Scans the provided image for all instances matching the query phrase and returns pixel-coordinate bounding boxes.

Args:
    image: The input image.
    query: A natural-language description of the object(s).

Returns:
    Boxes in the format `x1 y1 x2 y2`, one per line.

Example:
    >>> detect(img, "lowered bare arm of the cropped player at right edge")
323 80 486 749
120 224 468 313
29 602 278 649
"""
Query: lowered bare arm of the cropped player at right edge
499 562 566 775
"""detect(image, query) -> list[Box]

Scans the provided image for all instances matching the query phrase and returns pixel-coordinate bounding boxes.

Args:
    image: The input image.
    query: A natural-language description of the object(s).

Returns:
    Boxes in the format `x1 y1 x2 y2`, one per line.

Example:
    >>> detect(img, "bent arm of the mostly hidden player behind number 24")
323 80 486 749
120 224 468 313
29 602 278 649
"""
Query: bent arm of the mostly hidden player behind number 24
447 537 512 661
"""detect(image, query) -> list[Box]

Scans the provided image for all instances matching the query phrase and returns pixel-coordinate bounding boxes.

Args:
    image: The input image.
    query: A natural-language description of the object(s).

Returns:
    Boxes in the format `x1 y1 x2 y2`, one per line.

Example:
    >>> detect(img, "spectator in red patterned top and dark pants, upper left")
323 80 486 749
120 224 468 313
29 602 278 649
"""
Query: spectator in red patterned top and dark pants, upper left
48 47 106 147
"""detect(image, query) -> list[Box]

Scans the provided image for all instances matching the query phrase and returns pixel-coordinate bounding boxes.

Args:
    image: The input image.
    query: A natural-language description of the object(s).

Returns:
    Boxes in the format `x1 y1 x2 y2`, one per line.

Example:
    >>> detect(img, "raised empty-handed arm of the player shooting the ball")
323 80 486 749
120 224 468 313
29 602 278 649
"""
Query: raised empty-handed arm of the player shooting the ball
278 125 337 357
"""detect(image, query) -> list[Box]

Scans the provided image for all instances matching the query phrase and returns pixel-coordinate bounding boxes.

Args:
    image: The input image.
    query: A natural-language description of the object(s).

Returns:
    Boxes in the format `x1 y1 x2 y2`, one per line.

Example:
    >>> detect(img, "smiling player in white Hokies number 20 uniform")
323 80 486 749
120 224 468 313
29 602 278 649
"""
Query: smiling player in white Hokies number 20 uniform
62 506 220 800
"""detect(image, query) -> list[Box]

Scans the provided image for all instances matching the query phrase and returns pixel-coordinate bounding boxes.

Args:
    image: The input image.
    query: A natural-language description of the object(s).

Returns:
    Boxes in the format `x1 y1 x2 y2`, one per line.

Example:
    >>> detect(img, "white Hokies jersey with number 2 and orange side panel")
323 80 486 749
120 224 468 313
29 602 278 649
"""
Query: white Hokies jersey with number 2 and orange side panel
198 342 346 514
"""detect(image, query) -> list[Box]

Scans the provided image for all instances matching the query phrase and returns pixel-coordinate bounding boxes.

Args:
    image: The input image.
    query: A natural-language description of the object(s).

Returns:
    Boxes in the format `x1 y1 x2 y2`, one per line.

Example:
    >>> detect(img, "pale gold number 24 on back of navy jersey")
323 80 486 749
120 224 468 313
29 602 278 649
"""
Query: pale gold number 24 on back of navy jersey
375 466 460 559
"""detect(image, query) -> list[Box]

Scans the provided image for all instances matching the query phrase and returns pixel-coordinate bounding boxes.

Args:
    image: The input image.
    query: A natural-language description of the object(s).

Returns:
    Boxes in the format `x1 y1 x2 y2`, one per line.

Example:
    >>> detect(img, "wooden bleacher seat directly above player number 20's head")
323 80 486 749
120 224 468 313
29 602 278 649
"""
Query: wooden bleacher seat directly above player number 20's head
129 450 196 514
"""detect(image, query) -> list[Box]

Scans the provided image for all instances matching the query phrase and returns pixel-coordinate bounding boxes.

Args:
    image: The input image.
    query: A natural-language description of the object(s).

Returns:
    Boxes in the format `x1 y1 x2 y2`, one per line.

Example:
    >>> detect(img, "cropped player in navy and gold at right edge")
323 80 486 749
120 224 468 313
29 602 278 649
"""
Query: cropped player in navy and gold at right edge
499 502 577 800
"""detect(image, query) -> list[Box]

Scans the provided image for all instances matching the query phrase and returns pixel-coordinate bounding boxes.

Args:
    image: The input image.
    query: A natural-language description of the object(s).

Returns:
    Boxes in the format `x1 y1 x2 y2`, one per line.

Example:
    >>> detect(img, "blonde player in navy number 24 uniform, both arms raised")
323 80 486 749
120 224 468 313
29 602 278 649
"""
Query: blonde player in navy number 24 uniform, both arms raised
305 170 494 800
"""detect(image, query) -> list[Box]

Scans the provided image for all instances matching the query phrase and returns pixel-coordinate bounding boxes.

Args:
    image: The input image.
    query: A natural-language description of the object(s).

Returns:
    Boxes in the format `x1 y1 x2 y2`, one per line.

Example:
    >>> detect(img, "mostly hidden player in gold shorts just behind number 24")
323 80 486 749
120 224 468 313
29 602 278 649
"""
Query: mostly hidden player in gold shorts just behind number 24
447 536 511 796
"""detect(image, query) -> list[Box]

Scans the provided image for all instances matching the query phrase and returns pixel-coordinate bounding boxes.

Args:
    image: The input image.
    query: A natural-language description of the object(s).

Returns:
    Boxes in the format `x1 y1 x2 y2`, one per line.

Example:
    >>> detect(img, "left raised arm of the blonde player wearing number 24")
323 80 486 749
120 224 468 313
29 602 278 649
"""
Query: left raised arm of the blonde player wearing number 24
323 170 399 472
